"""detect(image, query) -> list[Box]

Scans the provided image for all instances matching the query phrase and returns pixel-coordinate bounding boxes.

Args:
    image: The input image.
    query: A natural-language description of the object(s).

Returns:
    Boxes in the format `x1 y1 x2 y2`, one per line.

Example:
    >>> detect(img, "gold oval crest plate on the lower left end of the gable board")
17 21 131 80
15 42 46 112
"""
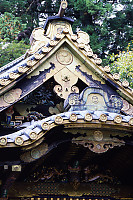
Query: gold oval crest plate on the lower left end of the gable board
0 88 22 107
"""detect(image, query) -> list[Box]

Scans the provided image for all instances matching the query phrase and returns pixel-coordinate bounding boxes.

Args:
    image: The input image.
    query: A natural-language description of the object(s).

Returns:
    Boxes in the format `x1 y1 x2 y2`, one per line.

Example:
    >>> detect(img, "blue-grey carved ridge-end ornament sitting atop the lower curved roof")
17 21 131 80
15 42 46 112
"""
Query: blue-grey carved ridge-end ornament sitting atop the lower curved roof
64 87 123 113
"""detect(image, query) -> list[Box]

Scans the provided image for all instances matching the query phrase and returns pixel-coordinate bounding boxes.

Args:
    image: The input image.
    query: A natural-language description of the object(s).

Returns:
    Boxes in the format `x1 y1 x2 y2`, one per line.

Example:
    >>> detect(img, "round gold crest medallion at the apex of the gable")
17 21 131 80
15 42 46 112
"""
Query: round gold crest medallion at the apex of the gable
56 49 73 65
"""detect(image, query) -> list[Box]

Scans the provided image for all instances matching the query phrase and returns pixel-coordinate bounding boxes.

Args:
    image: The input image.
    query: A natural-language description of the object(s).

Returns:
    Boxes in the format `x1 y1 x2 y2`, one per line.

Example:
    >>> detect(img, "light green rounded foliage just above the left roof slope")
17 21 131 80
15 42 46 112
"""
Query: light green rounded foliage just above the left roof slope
0 40 30 67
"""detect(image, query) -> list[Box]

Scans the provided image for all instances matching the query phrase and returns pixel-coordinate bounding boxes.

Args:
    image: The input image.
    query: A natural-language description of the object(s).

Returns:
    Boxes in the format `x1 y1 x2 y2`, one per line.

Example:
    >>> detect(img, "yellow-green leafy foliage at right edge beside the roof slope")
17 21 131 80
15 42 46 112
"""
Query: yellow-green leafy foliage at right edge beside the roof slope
110 42 133 88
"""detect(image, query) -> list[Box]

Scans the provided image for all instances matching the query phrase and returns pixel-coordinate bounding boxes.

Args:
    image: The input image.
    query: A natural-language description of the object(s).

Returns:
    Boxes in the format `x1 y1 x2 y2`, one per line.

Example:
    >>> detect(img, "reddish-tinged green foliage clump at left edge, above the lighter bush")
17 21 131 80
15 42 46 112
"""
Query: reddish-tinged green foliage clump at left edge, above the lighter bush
0 12 26 42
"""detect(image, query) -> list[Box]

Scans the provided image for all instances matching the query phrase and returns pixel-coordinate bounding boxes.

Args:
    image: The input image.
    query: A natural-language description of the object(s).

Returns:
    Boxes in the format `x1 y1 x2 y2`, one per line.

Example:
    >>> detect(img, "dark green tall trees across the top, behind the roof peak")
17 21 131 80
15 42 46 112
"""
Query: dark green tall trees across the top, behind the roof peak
0 0 133 64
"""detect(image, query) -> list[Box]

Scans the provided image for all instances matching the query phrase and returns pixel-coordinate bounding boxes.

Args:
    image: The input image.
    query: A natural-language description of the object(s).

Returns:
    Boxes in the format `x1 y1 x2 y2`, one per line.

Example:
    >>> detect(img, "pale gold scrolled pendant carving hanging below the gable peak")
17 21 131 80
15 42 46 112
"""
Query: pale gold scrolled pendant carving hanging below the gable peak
54 68 79 99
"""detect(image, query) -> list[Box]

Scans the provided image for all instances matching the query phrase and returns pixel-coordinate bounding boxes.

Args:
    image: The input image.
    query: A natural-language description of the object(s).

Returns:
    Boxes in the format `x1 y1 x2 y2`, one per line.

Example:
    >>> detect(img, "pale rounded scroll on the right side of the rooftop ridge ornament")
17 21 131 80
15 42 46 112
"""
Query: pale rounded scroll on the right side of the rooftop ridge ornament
77 31 90 44
